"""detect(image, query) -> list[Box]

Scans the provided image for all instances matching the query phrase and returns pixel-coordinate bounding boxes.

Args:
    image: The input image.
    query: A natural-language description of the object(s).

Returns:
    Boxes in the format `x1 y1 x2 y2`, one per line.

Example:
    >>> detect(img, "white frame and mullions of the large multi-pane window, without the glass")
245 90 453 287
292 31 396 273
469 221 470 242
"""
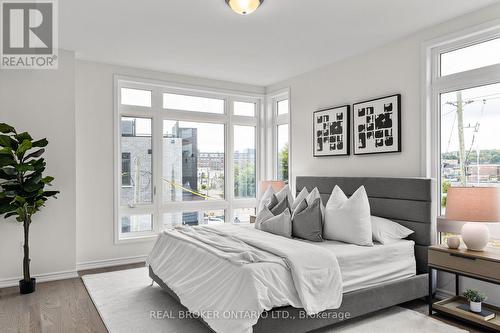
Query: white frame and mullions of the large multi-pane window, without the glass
113 75 265 244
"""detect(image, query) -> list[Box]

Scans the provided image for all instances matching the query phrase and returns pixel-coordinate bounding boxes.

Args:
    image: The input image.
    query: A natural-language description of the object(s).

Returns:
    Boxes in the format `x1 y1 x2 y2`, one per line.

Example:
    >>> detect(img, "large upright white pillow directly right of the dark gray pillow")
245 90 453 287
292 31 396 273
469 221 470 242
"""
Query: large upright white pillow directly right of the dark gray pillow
323 186 373 246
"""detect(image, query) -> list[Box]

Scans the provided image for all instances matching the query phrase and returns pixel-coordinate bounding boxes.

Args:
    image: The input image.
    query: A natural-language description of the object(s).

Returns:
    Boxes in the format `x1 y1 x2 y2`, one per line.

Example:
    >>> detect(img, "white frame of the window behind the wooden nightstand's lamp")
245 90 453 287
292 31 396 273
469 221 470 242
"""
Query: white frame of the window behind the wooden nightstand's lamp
421 20 500 218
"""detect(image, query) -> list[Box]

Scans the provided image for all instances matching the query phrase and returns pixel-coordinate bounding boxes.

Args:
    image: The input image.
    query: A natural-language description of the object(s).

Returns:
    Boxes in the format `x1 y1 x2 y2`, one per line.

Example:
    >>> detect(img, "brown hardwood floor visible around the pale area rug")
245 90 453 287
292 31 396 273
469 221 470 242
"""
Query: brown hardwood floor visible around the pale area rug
0 264 490 333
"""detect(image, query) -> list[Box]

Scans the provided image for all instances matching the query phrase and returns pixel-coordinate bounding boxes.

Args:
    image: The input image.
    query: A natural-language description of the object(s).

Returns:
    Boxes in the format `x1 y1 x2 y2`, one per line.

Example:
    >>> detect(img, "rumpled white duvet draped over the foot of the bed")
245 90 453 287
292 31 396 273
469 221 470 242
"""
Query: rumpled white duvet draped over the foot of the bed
147 224 342 333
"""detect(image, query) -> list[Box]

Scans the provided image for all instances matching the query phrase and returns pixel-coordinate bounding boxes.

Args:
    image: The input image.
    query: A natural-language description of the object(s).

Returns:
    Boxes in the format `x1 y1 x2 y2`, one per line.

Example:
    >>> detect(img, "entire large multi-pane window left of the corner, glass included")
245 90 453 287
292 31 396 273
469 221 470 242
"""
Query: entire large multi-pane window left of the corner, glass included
115 77 262 242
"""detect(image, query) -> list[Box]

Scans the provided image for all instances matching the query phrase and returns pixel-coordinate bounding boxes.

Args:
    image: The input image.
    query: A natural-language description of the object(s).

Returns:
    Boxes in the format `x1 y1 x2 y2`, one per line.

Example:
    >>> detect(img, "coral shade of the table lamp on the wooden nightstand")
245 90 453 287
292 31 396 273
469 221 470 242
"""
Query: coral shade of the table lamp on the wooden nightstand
446 187 500 222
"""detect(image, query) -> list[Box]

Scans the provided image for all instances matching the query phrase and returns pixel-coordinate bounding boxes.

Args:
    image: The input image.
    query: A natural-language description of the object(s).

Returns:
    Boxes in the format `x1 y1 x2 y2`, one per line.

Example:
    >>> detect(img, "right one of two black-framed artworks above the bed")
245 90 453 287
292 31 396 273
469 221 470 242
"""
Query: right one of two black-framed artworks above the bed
353 94 401 155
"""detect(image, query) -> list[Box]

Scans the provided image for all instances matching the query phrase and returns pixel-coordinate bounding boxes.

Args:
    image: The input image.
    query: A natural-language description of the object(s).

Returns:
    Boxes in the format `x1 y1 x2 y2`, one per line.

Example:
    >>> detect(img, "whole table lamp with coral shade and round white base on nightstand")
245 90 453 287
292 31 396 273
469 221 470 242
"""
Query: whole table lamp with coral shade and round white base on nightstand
446 187 500 251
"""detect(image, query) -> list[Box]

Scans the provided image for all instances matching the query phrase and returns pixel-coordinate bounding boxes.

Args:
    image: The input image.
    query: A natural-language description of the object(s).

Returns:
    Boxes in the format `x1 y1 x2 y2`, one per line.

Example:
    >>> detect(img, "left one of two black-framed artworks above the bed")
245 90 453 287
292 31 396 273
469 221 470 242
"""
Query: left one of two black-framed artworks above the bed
313 105 351 157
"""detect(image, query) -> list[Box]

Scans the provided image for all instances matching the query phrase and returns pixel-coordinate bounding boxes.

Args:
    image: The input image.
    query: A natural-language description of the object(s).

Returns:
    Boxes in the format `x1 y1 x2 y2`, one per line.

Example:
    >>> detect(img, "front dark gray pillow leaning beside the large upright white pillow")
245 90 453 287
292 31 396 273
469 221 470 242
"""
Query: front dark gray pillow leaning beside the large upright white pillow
292 198 323 242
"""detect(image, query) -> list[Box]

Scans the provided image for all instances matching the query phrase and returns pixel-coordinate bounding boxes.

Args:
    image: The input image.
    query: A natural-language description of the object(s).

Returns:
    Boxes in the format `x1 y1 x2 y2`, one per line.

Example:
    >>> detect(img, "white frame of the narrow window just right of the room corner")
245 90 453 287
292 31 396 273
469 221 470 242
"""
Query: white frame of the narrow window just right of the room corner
266 88 294 192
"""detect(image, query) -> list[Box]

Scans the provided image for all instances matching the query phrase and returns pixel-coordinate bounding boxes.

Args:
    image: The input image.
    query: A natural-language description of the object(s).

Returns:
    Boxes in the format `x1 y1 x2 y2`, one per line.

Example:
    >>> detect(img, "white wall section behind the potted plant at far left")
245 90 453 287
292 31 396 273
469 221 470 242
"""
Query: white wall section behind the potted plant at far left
0 51 76 285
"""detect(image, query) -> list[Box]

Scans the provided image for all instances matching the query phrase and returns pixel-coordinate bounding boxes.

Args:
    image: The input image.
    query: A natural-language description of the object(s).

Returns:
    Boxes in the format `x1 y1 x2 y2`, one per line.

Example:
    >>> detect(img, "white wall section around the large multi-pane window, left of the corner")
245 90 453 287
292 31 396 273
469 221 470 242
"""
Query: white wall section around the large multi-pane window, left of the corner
76 61 265 267
